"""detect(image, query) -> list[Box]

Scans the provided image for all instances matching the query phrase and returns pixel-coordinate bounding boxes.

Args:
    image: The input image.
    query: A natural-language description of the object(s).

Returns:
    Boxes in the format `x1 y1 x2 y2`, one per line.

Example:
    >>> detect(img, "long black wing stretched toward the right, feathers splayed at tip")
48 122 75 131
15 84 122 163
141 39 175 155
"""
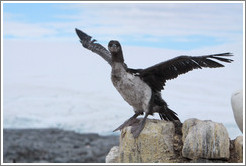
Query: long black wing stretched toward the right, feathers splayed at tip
139 53 233 91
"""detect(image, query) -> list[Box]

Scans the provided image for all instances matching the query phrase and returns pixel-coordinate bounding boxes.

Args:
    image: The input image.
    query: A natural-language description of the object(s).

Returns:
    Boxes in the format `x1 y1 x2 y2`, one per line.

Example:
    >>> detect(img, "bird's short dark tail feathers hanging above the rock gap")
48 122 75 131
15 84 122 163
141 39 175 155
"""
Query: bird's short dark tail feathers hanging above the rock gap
159 106 180 121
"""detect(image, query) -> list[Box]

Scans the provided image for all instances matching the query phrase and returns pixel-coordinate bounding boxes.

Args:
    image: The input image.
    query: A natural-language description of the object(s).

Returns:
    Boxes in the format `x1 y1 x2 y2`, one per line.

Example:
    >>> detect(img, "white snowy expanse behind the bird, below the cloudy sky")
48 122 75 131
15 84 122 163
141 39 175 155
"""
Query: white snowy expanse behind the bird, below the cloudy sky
3 40 243 138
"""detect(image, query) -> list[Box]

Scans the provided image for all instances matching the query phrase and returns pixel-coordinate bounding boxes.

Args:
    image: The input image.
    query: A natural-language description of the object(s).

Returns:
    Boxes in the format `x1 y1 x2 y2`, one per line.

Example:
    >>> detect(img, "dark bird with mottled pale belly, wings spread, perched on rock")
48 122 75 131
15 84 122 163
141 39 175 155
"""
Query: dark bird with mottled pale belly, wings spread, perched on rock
75 28 233 138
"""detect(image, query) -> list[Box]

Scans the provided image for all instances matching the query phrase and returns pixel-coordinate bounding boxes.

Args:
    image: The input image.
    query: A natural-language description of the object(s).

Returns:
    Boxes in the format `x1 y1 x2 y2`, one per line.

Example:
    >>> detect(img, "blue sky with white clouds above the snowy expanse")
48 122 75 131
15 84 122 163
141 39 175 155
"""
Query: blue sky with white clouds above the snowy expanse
3 3 243 50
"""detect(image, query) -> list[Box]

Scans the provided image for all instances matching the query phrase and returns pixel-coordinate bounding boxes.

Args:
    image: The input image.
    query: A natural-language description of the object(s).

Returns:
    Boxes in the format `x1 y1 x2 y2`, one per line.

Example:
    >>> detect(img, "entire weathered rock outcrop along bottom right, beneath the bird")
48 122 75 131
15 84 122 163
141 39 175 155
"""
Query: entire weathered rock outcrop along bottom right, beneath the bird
108 119 240 163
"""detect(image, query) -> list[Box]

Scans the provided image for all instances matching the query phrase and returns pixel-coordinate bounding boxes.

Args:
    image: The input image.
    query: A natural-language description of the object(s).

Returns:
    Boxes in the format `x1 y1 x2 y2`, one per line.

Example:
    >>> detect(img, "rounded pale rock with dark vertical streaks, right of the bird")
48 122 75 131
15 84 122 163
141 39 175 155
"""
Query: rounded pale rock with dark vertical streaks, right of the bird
182 119 230 159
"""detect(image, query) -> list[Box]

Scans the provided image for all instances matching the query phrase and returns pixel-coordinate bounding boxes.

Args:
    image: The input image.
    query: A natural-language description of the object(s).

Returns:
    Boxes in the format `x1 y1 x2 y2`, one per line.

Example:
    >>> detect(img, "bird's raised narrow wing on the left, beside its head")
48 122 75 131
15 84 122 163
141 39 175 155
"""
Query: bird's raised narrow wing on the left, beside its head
75 28 112 65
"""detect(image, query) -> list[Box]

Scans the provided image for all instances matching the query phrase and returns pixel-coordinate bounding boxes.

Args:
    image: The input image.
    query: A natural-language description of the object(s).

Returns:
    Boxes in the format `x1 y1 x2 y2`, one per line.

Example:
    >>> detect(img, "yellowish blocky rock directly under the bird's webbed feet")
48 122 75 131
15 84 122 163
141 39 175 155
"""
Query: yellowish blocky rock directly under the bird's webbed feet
119 119 175 163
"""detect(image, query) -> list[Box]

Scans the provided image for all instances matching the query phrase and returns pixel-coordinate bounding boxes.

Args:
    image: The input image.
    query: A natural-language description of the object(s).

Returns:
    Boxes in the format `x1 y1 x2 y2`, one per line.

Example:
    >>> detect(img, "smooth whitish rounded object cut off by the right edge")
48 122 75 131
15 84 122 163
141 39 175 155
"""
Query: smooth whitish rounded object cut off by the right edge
231 90 243 132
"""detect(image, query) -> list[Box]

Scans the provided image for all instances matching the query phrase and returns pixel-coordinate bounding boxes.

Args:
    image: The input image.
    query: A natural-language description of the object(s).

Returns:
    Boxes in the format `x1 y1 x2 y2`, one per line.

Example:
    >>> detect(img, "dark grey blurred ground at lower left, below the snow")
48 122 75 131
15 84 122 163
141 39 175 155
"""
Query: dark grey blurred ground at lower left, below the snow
3 128 119 163
